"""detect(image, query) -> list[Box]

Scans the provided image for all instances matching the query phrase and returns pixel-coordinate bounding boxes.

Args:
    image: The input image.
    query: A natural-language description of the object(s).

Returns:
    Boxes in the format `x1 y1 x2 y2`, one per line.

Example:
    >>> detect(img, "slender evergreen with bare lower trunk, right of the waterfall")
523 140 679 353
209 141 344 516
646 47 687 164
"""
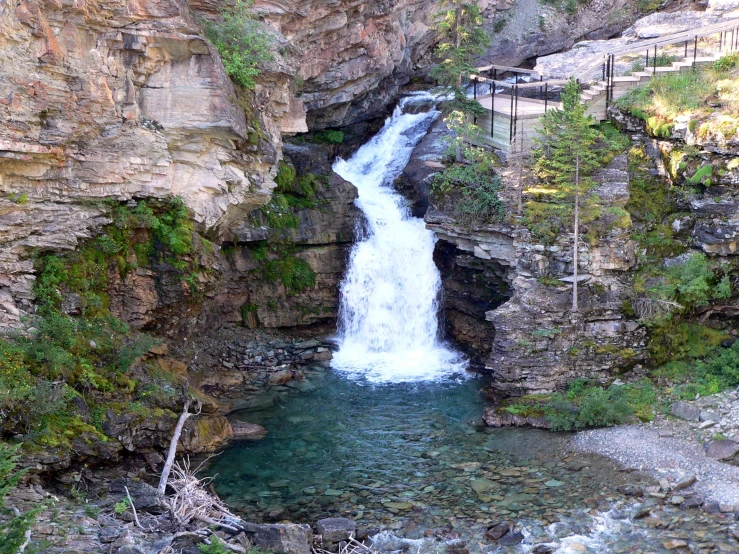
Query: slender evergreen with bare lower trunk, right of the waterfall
532 79 600 312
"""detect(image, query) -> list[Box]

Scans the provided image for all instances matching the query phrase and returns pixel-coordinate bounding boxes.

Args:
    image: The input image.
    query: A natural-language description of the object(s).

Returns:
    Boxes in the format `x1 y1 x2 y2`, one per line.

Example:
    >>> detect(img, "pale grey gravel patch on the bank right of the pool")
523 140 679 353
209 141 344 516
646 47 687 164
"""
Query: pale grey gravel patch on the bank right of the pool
572 420 739 508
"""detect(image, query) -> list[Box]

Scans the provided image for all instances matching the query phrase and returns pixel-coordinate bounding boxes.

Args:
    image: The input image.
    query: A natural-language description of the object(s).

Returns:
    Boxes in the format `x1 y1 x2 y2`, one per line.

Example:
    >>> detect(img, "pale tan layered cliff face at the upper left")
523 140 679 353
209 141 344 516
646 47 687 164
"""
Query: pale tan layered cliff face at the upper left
0 0 294 326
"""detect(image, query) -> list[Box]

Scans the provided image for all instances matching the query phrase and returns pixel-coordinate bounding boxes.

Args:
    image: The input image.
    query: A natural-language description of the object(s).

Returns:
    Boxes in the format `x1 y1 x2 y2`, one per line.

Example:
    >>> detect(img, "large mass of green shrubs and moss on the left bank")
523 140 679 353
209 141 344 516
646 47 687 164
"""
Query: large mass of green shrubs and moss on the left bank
0 199 209 464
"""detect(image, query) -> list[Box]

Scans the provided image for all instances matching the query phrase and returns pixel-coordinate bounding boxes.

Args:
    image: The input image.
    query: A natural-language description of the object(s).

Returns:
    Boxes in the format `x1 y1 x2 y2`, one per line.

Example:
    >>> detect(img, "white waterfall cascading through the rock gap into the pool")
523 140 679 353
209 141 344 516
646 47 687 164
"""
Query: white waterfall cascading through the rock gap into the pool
332 93 464 383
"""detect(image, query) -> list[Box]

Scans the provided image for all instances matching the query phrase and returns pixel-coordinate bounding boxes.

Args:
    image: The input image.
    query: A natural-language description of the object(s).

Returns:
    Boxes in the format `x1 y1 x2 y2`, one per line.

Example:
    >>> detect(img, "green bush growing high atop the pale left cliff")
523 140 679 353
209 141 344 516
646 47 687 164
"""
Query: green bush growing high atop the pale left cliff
203 0 275 89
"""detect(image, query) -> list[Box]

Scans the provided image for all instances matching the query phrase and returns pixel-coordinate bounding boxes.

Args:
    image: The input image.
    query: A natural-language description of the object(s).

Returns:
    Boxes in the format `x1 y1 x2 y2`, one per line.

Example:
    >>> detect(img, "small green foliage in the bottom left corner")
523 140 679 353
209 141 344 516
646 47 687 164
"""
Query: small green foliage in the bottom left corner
0 442 44 554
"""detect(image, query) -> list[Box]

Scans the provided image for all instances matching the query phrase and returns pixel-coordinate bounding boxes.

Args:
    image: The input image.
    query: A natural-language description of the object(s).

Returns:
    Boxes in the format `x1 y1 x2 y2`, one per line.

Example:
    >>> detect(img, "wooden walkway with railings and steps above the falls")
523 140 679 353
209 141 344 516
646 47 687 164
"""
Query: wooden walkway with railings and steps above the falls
470 19 739 152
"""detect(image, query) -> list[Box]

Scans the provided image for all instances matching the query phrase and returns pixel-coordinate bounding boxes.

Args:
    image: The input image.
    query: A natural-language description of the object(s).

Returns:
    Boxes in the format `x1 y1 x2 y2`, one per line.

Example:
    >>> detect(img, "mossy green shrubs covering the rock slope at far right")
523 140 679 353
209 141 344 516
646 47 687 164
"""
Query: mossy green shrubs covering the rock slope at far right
624 147 736 404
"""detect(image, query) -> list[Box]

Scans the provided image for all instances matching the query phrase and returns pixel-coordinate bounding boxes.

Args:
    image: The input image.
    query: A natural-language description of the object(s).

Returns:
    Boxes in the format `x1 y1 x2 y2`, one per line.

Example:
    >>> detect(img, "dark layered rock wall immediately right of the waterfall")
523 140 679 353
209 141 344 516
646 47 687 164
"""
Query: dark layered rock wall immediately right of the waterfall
426 156 646 396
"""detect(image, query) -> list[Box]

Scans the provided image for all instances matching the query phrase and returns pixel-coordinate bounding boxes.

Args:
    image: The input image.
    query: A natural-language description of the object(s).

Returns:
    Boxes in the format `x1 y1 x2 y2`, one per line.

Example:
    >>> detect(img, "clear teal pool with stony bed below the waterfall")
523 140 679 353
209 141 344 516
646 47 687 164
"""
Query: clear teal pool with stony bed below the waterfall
209 364 730 552
